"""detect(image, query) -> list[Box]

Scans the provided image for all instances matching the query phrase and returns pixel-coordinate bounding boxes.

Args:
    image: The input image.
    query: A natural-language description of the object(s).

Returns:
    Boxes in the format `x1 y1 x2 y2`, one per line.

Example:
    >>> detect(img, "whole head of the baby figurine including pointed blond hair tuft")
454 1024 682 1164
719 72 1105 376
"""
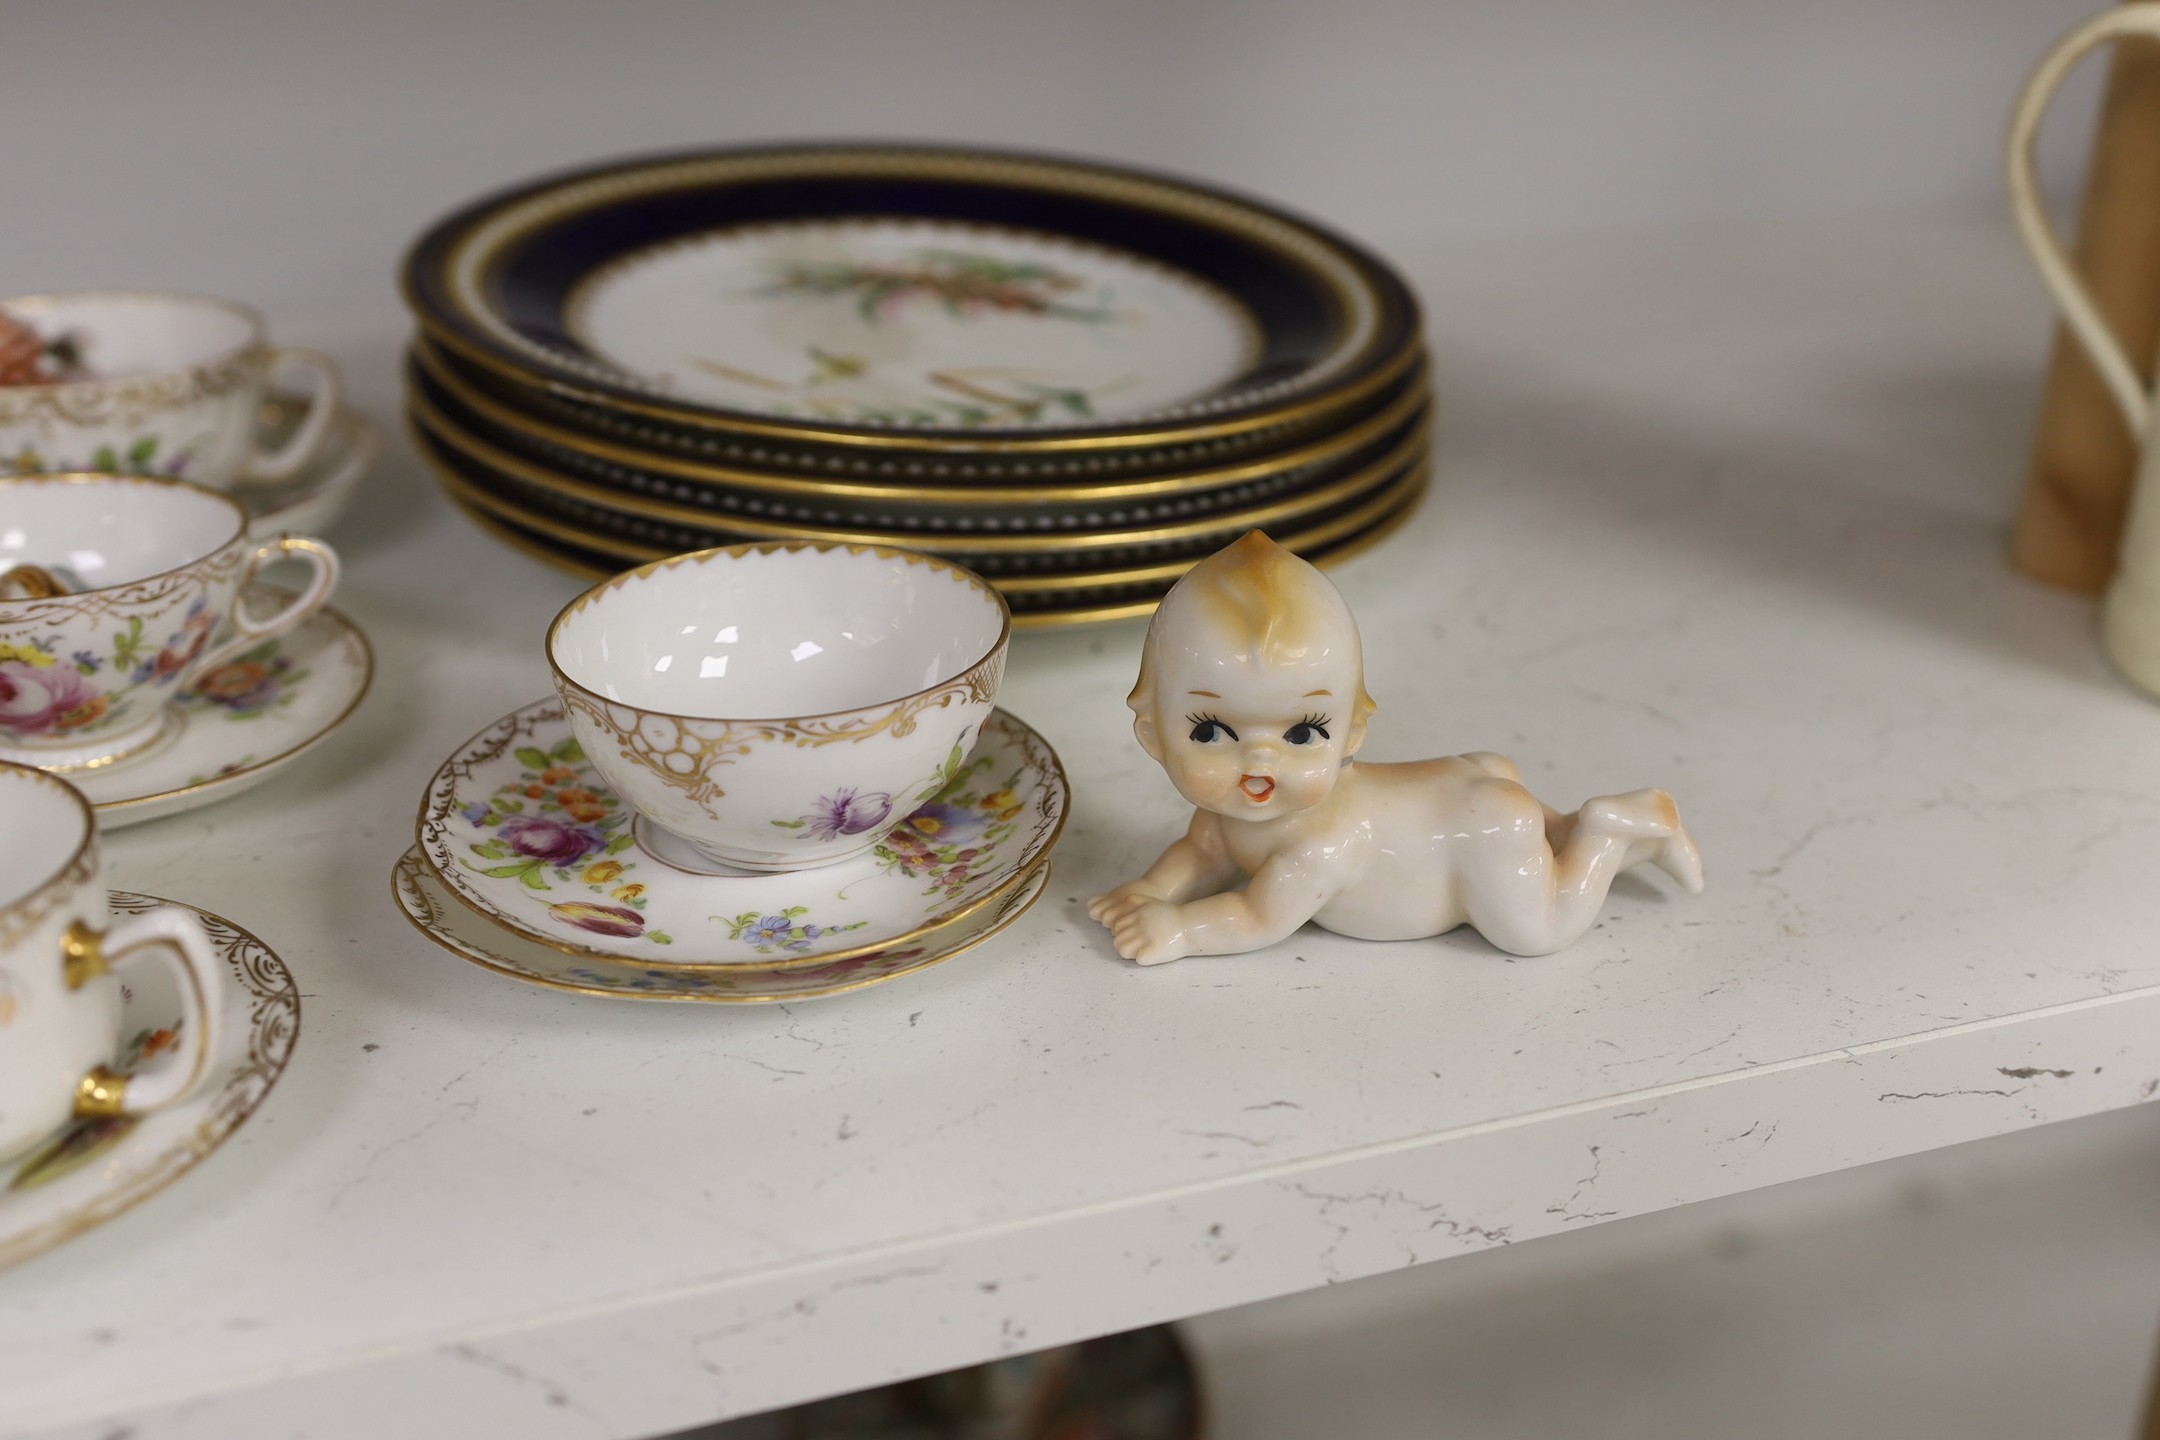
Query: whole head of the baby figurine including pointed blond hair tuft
1130 531 1372 820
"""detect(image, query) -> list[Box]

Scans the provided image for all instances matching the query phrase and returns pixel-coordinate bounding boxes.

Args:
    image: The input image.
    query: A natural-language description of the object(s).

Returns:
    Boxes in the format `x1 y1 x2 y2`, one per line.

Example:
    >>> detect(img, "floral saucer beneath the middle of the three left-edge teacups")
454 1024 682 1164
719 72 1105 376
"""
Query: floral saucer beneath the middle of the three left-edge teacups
67 595 376 831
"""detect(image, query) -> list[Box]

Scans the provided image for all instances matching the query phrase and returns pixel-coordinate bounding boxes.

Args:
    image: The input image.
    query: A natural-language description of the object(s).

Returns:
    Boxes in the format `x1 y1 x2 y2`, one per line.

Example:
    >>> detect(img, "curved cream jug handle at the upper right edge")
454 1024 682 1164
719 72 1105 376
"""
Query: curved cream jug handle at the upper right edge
2004 2 2160 447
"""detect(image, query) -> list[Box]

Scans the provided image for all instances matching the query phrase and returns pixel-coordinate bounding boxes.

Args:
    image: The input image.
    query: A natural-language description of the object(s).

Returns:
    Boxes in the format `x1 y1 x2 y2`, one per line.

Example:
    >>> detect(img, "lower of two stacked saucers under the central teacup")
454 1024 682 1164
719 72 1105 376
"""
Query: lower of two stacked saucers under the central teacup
403 846 1050 1004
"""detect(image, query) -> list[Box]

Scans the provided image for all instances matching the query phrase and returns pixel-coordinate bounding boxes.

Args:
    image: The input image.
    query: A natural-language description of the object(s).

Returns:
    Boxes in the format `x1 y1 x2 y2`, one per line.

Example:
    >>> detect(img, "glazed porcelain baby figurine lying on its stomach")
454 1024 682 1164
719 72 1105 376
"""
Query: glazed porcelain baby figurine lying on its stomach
1089 531 1702 965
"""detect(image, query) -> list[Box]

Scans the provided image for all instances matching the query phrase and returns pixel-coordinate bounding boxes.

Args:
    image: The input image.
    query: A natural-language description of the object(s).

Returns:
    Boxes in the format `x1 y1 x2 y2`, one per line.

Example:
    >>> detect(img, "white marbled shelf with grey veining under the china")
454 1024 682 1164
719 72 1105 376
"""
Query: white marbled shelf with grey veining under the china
0 222 2160 1440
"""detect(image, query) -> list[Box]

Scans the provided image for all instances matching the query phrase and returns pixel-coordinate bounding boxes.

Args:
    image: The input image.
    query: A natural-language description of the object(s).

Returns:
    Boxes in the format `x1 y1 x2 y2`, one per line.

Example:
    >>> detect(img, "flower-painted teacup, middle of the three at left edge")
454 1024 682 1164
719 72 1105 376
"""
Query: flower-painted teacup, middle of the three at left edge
0 475 337 769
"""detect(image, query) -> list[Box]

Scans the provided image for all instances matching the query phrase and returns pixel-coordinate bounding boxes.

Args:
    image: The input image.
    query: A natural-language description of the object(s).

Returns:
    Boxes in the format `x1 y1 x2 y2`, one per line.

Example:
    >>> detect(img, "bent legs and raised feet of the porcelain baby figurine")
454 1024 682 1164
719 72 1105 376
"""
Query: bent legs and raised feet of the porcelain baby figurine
1464 790 1702 954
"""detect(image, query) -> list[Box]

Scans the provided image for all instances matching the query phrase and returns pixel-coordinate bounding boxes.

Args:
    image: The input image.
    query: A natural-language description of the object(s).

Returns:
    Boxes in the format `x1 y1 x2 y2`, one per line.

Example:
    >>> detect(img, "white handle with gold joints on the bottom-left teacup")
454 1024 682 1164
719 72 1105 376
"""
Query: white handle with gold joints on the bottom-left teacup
60 907 227 1118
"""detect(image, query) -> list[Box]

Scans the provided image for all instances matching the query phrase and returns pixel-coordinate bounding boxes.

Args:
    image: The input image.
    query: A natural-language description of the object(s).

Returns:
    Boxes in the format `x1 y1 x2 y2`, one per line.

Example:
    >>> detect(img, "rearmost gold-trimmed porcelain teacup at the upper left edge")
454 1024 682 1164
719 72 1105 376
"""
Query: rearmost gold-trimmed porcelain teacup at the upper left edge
0 291 341 490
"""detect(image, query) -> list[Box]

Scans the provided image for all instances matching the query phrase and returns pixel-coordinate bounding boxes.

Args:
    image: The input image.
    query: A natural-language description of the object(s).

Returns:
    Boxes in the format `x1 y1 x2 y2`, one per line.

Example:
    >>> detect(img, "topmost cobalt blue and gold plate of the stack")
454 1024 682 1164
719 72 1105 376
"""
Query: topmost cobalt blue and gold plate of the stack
404 147 1419 456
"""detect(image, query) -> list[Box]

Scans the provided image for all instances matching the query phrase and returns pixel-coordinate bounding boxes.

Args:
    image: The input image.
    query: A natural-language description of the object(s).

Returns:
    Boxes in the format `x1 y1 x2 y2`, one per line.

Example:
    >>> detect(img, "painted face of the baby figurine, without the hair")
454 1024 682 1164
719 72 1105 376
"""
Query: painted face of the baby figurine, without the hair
1153 634 1363 820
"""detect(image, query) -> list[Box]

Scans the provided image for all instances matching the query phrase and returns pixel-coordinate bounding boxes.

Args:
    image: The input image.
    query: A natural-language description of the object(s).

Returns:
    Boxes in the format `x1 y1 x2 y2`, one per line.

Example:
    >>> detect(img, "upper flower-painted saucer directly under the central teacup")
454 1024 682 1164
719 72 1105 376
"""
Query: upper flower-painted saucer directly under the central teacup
417 697 1069 974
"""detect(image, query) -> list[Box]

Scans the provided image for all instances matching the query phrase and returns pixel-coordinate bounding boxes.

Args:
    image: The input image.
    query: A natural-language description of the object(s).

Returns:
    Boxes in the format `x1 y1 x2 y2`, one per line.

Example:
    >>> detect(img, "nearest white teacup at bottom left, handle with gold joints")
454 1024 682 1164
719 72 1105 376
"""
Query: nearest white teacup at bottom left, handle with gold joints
0 762 227 1159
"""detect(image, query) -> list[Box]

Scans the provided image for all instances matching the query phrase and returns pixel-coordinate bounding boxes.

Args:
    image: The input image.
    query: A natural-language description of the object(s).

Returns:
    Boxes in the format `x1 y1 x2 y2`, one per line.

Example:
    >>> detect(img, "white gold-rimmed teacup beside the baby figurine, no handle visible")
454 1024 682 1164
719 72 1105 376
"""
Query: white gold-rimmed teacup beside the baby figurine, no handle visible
546 542 1011 870
